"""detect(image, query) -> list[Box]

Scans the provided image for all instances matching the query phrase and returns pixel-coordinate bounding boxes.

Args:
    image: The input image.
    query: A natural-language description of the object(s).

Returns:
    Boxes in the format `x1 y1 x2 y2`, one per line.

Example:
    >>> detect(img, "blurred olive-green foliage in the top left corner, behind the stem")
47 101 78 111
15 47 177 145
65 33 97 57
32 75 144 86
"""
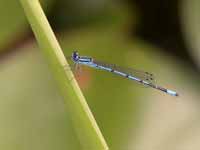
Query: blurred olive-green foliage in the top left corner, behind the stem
0 0 52 51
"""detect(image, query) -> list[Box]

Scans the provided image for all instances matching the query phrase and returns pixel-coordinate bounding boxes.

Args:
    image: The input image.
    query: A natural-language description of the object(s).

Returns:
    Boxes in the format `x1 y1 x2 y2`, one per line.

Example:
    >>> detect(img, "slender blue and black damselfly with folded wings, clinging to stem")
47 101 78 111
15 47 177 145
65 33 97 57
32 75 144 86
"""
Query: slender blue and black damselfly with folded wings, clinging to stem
68 51 178 96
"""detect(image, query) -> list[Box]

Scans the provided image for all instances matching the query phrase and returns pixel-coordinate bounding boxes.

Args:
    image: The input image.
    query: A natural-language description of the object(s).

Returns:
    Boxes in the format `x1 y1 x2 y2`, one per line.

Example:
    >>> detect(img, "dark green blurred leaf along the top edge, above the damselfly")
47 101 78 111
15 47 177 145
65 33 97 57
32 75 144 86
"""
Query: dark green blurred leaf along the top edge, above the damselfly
49 0 135 30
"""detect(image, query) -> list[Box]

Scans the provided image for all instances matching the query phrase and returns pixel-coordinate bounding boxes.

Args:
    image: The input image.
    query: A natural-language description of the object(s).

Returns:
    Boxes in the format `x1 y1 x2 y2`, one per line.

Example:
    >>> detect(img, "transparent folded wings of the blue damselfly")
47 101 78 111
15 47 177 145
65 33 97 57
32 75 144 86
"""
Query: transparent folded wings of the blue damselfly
93 60 155 83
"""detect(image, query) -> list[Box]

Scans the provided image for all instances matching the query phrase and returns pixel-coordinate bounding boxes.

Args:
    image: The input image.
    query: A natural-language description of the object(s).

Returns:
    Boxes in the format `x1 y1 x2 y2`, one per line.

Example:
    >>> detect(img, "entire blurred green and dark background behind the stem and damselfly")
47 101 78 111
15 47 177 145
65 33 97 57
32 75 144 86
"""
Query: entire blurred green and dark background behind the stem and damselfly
0 0 200 150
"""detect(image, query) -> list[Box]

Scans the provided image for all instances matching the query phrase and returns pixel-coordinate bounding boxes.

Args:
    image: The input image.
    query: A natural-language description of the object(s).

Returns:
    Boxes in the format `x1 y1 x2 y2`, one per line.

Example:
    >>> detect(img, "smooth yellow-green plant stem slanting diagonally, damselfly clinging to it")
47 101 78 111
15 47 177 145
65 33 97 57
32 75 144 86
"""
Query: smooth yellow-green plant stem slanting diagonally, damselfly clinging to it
20 0 108 150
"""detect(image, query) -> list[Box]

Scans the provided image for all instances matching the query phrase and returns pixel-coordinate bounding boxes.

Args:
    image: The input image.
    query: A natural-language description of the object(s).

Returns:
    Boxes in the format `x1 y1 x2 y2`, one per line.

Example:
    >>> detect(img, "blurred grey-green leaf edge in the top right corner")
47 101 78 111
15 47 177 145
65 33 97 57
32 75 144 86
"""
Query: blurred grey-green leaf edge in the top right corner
181 0 200 66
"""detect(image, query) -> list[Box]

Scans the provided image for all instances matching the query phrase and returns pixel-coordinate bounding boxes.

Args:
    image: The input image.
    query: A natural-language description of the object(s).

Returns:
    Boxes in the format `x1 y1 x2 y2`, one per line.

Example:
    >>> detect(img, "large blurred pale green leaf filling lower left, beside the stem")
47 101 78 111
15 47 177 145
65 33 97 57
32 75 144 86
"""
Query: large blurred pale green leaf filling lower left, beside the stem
0 46 80 150
